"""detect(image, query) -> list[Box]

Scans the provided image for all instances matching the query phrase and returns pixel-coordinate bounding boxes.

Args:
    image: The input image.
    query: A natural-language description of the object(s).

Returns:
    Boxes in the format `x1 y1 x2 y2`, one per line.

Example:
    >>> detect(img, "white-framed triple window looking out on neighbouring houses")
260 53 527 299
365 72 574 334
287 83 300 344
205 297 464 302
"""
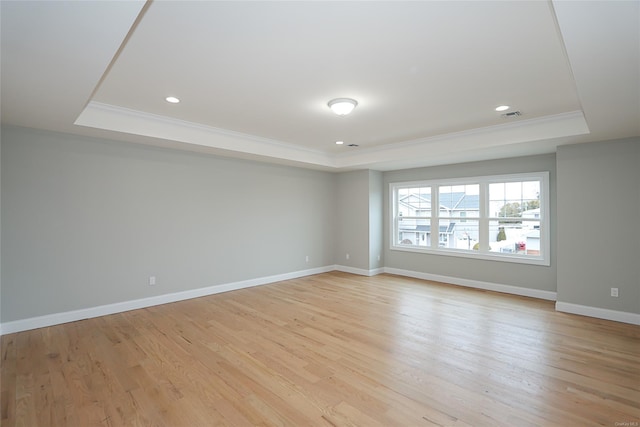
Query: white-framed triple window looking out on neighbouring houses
389 172 549 265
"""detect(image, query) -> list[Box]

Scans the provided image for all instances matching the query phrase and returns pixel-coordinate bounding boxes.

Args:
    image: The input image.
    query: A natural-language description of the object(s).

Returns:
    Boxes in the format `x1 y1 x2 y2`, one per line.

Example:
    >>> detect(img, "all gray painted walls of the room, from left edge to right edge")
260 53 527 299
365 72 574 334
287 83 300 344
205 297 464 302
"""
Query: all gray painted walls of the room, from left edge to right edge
0 128 640 322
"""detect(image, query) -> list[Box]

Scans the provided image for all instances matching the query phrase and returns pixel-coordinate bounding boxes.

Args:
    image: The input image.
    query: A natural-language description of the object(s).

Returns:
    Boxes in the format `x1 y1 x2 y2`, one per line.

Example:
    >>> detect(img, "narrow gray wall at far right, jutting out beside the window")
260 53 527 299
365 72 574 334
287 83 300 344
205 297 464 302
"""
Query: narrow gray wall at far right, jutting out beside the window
557 138 640 313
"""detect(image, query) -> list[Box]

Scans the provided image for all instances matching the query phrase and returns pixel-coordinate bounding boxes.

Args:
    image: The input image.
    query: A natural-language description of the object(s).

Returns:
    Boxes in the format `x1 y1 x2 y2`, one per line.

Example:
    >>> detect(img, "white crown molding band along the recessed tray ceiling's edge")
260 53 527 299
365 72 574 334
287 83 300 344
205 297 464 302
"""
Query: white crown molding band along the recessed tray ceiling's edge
74 101 589 170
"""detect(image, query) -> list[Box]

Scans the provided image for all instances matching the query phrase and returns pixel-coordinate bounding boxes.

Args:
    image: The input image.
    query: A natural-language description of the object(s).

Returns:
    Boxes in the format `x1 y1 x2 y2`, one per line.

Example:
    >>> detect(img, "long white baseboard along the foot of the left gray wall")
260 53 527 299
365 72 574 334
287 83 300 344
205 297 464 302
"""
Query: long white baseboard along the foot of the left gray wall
0 265 336 335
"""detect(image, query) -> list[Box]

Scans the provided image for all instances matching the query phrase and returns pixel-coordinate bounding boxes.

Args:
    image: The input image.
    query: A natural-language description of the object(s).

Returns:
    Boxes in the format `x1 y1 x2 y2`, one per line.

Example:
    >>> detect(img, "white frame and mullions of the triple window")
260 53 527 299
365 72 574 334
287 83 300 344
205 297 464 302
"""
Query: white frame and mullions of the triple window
389 171 551 266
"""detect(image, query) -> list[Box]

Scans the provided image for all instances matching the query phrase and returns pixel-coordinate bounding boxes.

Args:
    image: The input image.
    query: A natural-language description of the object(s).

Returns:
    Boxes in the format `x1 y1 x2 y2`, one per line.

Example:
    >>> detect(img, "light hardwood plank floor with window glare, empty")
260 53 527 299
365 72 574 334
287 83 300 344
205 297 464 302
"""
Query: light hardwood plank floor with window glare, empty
1 272 640 427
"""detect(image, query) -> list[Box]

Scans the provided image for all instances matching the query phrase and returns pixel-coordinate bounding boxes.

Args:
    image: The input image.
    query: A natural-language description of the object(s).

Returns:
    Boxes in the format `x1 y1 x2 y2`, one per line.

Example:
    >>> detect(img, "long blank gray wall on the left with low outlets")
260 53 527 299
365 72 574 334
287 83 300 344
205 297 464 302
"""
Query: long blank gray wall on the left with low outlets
0 128 338 322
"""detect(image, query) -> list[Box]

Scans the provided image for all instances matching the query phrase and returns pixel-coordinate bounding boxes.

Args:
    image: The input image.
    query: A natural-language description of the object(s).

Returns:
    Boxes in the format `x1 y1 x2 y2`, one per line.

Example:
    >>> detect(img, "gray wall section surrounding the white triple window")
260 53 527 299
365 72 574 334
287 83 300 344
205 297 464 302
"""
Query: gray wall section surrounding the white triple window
384 154 556 292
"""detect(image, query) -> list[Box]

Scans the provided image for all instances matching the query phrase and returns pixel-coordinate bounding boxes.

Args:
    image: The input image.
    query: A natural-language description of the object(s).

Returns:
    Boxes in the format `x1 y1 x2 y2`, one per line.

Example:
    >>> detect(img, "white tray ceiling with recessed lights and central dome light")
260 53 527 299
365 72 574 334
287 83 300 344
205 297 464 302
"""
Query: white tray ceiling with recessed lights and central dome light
0 0 640 170
